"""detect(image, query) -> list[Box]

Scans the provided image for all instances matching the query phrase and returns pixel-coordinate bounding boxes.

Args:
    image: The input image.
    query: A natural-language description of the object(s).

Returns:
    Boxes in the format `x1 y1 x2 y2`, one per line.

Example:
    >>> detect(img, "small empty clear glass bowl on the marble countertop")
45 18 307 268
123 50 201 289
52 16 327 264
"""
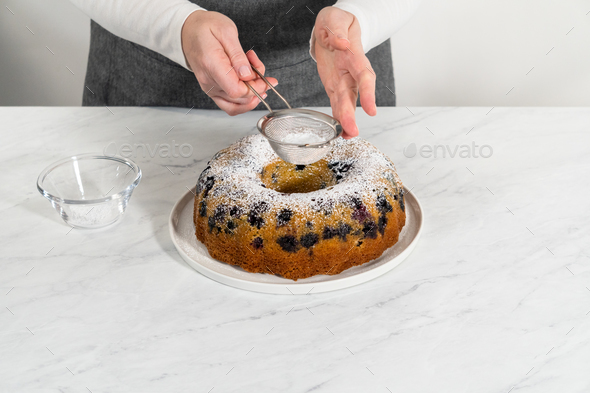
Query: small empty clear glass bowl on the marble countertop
37 154 141 228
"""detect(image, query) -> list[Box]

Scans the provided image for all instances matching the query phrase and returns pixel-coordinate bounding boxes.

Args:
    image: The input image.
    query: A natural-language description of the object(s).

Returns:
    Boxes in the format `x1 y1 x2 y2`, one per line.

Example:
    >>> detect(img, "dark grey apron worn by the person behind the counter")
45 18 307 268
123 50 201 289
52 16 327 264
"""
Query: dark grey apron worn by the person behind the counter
82 0 395 110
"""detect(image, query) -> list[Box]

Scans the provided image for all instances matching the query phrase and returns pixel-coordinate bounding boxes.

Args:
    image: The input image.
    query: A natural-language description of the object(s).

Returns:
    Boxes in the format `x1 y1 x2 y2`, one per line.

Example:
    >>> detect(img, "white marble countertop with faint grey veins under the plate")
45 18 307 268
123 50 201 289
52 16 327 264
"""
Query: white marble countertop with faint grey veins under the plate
0 108 590 393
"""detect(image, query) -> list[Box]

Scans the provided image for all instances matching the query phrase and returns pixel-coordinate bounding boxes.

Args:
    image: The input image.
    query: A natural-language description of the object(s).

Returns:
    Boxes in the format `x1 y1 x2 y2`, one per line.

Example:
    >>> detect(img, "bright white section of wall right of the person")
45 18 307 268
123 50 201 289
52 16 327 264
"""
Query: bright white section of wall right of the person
392 0 590 106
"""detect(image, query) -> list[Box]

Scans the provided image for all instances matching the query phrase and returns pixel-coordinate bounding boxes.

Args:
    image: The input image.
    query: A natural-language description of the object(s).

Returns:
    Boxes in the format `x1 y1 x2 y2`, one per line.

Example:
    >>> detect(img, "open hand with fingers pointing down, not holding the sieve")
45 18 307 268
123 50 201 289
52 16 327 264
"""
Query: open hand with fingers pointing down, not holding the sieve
314 7 377 139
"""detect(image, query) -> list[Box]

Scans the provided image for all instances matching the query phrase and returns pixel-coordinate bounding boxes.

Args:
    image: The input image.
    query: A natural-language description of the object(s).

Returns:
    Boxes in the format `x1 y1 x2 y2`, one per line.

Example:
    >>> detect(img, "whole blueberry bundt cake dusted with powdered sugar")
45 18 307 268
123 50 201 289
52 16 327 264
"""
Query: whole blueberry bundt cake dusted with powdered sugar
194 135 406 280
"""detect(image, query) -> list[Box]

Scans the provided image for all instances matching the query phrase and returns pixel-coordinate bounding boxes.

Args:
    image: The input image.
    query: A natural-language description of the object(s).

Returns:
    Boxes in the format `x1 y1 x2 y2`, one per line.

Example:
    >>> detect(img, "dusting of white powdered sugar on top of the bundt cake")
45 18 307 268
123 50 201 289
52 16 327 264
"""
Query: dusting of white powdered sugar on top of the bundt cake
197 134 402 212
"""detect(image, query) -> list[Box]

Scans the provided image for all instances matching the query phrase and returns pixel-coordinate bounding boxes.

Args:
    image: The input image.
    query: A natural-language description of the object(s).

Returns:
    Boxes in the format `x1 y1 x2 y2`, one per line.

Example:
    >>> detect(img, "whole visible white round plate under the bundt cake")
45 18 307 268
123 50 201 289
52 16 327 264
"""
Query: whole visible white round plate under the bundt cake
169 187 424 295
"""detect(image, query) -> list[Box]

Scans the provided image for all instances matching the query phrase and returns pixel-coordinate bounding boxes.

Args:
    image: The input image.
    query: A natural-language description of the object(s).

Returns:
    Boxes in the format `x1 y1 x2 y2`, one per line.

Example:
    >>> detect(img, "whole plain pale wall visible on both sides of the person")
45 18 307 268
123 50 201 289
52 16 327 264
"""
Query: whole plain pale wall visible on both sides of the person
0 0 590 106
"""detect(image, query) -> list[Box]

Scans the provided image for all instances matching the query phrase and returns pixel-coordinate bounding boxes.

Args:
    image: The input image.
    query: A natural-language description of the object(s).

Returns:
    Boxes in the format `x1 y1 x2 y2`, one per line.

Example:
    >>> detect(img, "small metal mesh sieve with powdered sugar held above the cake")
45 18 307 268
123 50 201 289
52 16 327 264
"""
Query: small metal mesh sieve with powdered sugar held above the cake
244 66 342 165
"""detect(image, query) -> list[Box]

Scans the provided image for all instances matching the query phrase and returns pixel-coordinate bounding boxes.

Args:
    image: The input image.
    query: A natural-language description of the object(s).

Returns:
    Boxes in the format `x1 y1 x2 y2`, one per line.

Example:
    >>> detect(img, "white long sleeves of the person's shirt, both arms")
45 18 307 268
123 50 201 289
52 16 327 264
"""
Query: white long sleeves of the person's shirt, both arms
71 0 420 69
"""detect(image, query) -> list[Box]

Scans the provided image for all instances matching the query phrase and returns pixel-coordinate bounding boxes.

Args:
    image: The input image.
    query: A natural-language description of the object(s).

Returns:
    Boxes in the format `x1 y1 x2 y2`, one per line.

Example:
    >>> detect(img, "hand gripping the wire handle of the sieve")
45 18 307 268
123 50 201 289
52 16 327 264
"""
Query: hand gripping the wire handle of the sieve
182 11 278 116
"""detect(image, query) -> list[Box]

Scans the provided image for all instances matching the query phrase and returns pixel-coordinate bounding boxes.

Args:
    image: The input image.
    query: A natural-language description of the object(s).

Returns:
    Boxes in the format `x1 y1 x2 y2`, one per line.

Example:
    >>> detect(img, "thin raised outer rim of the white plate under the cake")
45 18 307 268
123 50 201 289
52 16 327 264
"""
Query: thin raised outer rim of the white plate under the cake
168 186 424 295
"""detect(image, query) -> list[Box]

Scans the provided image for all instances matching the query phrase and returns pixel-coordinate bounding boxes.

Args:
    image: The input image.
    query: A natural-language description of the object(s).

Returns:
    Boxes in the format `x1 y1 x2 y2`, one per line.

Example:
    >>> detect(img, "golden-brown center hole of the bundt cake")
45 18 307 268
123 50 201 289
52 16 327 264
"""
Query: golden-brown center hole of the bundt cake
261 159 336 194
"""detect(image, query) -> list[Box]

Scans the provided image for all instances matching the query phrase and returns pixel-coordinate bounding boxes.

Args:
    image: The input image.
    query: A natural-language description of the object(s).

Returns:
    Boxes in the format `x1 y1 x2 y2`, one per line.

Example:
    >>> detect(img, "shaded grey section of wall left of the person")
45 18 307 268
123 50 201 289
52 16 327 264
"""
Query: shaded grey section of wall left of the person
0 0 90 105
